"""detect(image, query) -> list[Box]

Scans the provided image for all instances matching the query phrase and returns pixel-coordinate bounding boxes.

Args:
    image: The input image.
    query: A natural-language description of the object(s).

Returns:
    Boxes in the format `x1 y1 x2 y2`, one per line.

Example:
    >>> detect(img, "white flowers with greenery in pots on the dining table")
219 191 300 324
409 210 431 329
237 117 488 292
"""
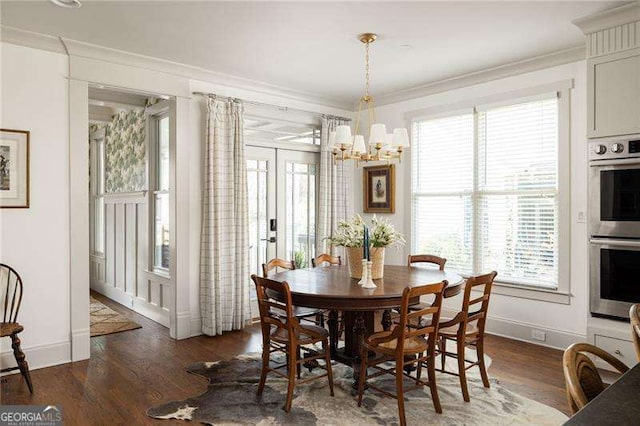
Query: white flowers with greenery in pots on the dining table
327 214 406 247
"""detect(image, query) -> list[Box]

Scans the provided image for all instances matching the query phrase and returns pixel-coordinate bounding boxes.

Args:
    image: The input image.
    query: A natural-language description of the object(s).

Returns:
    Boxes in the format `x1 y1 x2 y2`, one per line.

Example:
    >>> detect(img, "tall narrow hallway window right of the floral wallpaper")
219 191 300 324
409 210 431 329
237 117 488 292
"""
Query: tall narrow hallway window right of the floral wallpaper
150 114 170 269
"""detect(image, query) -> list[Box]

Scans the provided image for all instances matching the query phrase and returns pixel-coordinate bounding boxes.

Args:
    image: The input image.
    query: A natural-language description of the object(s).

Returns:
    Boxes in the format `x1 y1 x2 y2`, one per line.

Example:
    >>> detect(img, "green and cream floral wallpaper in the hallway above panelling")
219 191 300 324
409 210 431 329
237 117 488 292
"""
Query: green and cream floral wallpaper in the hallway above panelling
90 110 147 194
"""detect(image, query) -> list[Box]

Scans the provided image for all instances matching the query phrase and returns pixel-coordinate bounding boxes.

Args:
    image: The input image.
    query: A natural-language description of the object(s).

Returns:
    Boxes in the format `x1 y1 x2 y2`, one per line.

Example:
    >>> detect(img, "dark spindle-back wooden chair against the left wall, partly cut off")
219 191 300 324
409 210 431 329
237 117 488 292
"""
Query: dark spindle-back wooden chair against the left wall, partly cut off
0 263 33 393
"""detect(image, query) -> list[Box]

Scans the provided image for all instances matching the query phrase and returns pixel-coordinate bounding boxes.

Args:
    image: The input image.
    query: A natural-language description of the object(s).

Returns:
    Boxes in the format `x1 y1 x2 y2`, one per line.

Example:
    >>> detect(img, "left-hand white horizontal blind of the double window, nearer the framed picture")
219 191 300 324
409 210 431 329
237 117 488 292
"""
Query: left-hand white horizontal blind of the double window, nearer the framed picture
411 113 474 272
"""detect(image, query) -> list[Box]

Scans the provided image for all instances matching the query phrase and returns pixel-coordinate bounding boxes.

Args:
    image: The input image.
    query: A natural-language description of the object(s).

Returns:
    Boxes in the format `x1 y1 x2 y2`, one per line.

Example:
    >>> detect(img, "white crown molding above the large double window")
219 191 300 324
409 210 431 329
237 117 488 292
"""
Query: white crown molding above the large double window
376 46 586 106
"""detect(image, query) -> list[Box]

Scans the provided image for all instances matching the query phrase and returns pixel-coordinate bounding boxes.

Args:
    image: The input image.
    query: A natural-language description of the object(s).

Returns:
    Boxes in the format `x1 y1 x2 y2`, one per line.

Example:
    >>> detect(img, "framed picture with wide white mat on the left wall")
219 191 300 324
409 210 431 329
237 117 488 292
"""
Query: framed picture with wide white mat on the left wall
0 129 29 208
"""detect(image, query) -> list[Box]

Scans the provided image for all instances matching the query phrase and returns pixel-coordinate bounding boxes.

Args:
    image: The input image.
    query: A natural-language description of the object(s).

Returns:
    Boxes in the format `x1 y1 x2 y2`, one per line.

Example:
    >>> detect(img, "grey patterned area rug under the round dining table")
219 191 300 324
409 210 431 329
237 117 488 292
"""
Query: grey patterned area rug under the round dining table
147 354 567 426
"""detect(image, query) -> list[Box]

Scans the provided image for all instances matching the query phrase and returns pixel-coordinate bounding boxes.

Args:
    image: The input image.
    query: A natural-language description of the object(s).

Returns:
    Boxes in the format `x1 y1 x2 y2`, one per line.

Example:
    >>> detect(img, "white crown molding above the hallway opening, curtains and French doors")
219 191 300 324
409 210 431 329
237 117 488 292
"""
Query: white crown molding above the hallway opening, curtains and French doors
0 26 352 111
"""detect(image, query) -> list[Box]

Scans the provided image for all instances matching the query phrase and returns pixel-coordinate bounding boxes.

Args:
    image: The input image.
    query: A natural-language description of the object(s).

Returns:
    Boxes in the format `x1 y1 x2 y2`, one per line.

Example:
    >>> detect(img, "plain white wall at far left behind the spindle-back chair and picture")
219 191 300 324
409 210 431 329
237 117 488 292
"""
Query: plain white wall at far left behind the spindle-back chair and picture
0 43 70 366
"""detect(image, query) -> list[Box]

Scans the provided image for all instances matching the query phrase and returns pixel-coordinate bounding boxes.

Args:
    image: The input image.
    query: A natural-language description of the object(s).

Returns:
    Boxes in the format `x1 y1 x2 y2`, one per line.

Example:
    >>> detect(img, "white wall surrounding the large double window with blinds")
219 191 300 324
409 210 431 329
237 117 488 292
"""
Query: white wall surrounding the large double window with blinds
356 61 588 347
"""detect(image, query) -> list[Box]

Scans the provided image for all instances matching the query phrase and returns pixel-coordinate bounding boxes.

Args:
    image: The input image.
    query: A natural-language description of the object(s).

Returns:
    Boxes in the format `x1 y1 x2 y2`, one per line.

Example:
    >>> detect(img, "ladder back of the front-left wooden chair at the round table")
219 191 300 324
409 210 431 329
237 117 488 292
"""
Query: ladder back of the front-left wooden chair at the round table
251 274 298 333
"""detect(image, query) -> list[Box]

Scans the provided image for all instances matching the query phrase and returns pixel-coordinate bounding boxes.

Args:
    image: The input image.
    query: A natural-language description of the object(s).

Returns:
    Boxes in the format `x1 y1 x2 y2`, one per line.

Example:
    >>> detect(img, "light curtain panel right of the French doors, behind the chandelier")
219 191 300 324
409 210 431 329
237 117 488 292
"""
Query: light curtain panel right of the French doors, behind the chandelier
316 117 354 257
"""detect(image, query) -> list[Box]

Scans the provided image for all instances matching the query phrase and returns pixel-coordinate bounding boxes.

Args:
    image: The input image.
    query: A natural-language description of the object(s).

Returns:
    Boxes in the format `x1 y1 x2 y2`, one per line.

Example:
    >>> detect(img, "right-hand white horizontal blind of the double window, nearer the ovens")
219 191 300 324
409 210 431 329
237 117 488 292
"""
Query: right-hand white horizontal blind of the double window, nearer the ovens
477 97 558 287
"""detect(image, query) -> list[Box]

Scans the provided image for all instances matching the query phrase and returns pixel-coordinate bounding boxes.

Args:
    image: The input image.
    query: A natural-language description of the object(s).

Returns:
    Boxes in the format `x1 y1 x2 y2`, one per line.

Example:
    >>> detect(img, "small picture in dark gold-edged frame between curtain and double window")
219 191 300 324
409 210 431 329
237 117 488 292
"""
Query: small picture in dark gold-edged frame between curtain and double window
363 164 396 213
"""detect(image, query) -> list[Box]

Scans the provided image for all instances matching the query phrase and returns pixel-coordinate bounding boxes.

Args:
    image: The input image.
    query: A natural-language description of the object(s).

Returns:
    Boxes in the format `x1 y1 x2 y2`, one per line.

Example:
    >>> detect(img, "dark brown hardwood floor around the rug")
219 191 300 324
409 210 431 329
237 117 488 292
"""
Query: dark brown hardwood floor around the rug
0 295 568 426
